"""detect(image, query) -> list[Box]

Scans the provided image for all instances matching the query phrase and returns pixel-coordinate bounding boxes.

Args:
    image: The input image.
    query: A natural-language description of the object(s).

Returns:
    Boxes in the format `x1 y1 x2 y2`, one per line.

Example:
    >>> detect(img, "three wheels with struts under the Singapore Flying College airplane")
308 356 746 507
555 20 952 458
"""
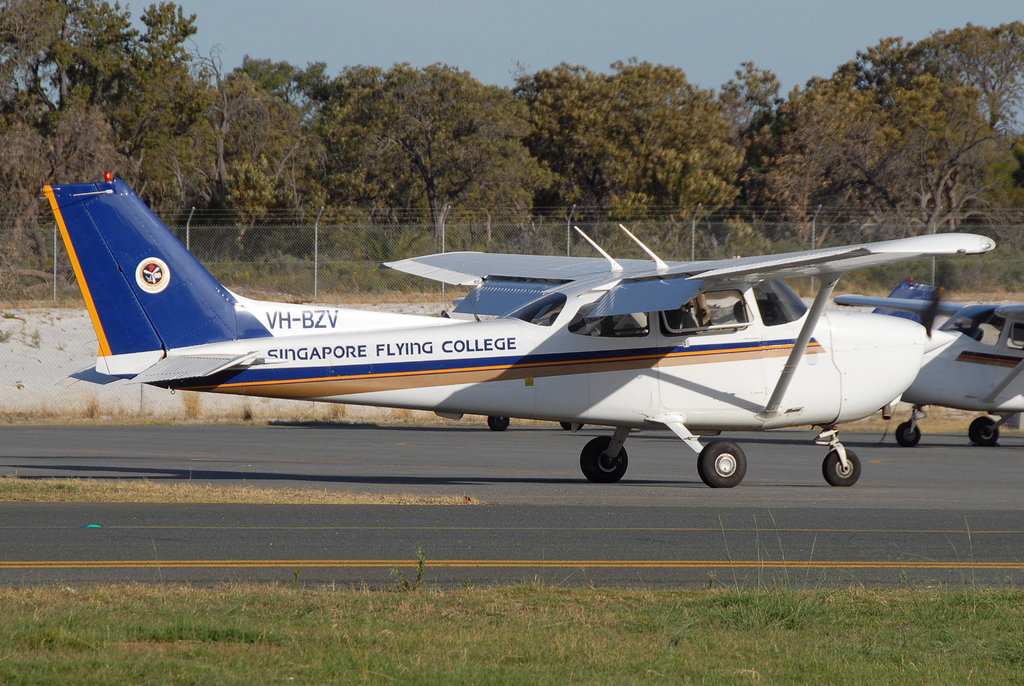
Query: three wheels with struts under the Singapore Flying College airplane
580 421 860 488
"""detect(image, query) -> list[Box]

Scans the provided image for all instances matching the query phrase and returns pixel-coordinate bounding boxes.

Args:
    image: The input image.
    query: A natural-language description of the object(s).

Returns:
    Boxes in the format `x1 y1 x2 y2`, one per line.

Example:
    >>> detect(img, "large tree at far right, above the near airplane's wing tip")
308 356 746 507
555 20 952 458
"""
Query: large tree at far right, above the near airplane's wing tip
764 27 1022 233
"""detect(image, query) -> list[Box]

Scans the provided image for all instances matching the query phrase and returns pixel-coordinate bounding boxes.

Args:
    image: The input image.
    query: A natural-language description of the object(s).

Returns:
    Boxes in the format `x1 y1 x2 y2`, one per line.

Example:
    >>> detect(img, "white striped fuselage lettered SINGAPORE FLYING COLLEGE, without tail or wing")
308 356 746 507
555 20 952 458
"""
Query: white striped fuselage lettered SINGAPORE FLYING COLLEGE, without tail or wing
170 291 924 433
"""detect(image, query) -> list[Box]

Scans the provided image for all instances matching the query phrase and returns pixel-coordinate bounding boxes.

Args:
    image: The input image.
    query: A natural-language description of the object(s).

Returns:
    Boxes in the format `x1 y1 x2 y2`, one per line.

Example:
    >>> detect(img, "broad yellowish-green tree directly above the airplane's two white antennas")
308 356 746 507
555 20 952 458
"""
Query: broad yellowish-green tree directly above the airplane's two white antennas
514 60 741 220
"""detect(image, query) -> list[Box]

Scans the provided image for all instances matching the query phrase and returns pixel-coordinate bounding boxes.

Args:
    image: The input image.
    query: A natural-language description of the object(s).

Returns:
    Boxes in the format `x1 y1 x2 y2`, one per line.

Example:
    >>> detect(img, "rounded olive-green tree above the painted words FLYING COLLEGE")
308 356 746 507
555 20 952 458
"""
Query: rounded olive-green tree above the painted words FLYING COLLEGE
315 63 544 237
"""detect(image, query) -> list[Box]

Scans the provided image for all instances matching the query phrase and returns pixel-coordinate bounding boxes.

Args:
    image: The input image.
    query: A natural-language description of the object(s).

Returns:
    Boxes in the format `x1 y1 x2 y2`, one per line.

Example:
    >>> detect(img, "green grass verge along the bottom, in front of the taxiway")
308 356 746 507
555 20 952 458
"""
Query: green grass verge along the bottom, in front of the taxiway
0 586 1024 684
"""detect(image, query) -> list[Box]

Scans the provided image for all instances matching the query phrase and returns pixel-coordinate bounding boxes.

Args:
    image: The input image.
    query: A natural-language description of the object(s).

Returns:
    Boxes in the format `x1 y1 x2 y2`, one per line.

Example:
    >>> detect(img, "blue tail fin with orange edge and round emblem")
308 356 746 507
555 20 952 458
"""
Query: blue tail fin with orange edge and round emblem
43 179 270 376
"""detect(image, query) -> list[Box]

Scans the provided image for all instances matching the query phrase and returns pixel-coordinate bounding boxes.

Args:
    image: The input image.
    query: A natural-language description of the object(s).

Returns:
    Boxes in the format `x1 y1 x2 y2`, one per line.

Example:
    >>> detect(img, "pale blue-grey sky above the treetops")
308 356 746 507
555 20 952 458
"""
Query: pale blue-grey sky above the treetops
163 0 1024 94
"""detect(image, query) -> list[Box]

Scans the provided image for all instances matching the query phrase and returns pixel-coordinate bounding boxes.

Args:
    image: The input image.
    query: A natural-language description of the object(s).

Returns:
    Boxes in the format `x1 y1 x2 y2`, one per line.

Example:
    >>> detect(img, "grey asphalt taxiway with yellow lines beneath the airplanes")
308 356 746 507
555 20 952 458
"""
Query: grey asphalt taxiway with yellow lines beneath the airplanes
0 425 1024 588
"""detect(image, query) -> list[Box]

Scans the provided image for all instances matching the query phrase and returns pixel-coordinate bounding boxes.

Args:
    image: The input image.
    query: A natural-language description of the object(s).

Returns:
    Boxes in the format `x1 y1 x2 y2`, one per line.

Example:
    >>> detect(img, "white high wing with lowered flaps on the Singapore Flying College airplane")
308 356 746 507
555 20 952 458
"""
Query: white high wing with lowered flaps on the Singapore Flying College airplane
385 233 995 316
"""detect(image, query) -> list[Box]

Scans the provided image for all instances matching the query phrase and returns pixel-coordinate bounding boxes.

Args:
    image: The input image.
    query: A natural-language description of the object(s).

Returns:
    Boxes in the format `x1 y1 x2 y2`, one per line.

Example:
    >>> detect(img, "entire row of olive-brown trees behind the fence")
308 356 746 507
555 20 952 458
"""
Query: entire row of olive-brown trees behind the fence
0 0 1024 266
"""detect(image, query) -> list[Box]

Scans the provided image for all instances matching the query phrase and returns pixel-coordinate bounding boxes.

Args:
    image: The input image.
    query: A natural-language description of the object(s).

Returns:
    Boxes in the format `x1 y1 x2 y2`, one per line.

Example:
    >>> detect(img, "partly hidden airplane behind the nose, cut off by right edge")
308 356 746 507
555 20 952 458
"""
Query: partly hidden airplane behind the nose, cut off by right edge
836 282 1024 447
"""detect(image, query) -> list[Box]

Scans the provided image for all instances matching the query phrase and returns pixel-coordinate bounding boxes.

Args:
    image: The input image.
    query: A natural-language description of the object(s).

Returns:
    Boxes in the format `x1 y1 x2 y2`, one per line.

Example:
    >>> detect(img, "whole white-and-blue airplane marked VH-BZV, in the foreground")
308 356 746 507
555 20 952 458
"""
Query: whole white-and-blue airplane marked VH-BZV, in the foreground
44 179 994 487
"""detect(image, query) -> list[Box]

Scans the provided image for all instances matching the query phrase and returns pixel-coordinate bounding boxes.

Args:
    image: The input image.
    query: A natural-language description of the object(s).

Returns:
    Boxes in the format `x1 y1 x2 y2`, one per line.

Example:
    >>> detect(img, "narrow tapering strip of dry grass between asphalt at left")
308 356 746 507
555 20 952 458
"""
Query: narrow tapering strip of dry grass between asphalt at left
0 476 480 505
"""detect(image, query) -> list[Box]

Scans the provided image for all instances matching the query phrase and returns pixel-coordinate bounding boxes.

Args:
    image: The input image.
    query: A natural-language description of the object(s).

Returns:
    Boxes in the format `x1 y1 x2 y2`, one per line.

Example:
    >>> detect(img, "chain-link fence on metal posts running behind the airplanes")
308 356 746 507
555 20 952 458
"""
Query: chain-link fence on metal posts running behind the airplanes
6 207 1024 306
